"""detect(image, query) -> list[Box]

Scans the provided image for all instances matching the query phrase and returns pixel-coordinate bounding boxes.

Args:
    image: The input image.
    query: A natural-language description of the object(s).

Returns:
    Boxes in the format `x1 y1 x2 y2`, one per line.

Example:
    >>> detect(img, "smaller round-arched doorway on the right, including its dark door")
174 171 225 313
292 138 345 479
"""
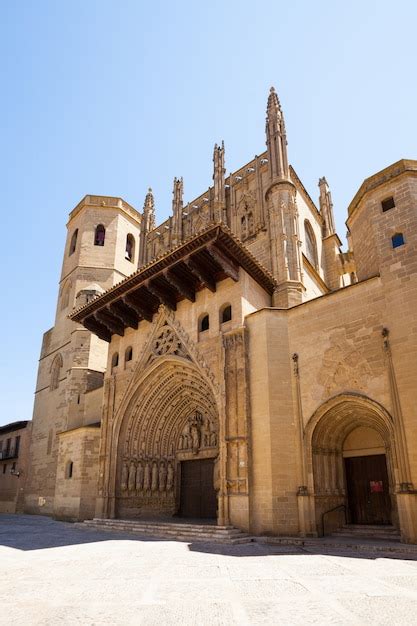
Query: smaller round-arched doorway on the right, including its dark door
306 394 398 533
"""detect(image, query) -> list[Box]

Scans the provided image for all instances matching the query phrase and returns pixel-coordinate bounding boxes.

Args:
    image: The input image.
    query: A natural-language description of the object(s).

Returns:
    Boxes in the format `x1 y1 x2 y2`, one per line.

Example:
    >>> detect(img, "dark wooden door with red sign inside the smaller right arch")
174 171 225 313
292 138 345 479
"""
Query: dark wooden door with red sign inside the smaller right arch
345 454 391 524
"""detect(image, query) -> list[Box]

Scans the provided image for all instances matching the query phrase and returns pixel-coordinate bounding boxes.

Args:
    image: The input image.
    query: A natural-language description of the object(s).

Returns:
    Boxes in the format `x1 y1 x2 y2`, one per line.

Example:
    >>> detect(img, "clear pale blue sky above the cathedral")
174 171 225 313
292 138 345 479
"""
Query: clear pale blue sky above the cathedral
0 0 417 424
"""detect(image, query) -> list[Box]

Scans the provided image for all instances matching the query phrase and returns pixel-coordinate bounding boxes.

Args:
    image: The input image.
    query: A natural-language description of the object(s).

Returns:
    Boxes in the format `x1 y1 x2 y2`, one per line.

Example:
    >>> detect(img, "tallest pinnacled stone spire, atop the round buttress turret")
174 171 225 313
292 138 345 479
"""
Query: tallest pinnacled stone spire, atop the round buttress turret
265 87 289 181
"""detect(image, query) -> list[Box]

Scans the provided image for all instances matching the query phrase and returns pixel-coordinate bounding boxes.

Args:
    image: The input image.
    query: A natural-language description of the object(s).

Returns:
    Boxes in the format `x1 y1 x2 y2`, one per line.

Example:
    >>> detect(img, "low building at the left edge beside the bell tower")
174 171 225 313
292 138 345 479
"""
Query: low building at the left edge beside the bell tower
0 420 32 513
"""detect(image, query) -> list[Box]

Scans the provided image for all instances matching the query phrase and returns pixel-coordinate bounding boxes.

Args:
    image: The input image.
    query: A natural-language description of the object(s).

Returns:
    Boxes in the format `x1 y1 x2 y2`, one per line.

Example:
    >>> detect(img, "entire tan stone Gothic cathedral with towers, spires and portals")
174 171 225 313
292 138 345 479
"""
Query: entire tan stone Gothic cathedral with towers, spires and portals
25 88 417 542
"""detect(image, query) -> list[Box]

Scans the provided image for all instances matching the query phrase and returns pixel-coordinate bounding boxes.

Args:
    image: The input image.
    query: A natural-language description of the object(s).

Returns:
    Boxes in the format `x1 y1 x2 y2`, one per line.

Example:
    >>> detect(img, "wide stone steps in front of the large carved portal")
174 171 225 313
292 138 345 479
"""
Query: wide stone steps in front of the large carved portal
74 518 252 545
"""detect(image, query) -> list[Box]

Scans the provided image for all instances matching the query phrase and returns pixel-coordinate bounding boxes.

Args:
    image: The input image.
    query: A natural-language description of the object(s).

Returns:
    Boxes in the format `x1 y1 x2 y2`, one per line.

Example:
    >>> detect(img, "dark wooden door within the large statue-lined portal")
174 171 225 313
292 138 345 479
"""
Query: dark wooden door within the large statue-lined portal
179 459 217 519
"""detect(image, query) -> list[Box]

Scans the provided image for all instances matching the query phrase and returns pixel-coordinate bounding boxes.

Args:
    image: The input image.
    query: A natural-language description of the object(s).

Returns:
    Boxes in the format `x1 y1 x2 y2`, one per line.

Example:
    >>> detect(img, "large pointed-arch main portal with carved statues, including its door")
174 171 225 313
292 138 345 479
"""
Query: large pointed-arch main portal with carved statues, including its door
115 356 219 519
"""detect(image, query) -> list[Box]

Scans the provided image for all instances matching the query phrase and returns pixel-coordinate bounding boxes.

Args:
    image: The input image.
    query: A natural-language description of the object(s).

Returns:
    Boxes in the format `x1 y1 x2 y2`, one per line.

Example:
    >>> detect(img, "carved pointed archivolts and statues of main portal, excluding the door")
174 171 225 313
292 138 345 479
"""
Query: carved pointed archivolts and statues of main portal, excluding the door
117 356 218 501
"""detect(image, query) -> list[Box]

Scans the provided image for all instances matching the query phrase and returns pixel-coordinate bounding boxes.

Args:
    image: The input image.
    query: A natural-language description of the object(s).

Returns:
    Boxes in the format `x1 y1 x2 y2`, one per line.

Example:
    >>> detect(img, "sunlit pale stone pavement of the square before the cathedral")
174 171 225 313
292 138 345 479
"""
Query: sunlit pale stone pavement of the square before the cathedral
0 515 417 626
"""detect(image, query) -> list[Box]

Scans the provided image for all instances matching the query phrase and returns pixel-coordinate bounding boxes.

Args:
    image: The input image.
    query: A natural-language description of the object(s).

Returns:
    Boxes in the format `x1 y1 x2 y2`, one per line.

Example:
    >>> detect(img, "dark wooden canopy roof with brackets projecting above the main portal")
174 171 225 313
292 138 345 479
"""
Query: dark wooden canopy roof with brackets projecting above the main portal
69 225 276 341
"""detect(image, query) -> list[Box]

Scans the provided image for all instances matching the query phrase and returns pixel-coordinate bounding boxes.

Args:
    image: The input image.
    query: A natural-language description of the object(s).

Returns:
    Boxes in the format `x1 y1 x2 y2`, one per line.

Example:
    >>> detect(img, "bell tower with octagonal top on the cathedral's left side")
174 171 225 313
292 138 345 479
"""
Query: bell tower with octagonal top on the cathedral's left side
25 195 141 515
